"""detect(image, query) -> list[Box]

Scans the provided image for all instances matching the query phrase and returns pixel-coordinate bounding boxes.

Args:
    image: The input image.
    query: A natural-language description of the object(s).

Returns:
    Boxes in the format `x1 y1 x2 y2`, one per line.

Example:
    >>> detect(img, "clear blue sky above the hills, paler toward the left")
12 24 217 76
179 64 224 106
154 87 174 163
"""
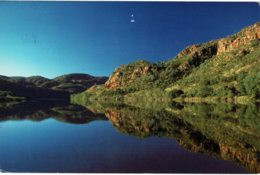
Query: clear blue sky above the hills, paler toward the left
0 1 260 78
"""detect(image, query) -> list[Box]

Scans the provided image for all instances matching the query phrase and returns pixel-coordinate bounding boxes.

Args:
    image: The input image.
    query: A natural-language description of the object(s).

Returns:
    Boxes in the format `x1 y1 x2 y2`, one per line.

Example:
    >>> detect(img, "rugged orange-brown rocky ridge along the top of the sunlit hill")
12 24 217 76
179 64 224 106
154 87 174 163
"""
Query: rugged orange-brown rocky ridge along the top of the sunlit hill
105 23 260 89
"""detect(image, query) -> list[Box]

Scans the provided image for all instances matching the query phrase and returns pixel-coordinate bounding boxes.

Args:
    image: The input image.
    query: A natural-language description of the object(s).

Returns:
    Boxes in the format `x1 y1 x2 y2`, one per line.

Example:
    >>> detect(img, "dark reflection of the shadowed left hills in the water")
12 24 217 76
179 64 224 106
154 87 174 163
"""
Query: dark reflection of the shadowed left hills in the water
0 100 106 124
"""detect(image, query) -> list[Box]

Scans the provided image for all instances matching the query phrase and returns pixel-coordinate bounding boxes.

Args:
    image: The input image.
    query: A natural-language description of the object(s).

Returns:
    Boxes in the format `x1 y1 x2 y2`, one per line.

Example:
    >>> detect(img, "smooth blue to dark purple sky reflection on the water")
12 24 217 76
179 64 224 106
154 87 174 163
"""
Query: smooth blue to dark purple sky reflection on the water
0 119 246 172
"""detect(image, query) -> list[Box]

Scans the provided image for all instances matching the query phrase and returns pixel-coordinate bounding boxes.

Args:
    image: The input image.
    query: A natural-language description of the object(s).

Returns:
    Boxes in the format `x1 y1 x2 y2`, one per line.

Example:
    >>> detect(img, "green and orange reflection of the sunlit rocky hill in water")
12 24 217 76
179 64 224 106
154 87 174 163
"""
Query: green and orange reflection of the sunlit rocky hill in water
86 104 260 172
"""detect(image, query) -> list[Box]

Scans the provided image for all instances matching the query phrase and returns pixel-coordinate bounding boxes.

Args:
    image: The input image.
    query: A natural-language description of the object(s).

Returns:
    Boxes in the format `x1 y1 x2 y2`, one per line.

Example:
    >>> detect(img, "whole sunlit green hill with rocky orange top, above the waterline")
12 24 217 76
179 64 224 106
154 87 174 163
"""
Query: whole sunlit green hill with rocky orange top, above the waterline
71 22 260 103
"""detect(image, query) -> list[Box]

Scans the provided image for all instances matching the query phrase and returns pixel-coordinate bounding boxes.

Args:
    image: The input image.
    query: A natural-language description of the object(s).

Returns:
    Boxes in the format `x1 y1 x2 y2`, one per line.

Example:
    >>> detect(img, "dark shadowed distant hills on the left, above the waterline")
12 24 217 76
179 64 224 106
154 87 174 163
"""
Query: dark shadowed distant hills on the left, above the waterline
0 74 107 101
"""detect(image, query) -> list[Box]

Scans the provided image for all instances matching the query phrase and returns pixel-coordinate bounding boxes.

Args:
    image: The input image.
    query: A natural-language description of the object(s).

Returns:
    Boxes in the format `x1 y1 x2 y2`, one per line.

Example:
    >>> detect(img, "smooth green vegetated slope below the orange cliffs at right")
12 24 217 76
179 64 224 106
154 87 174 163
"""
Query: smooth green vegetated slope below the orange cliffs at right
169 42 260 100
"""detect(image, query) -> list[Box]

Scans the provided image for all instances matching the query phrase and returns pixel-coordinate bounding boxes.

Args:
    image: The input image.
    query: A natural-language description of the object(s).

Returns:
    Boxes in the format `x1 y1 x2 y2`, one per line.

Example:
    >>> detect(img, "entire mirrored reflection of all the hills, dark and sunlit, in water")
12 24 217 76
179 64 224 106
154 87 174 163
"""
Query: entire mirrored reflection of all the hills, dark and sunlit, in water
0 101 260 172
